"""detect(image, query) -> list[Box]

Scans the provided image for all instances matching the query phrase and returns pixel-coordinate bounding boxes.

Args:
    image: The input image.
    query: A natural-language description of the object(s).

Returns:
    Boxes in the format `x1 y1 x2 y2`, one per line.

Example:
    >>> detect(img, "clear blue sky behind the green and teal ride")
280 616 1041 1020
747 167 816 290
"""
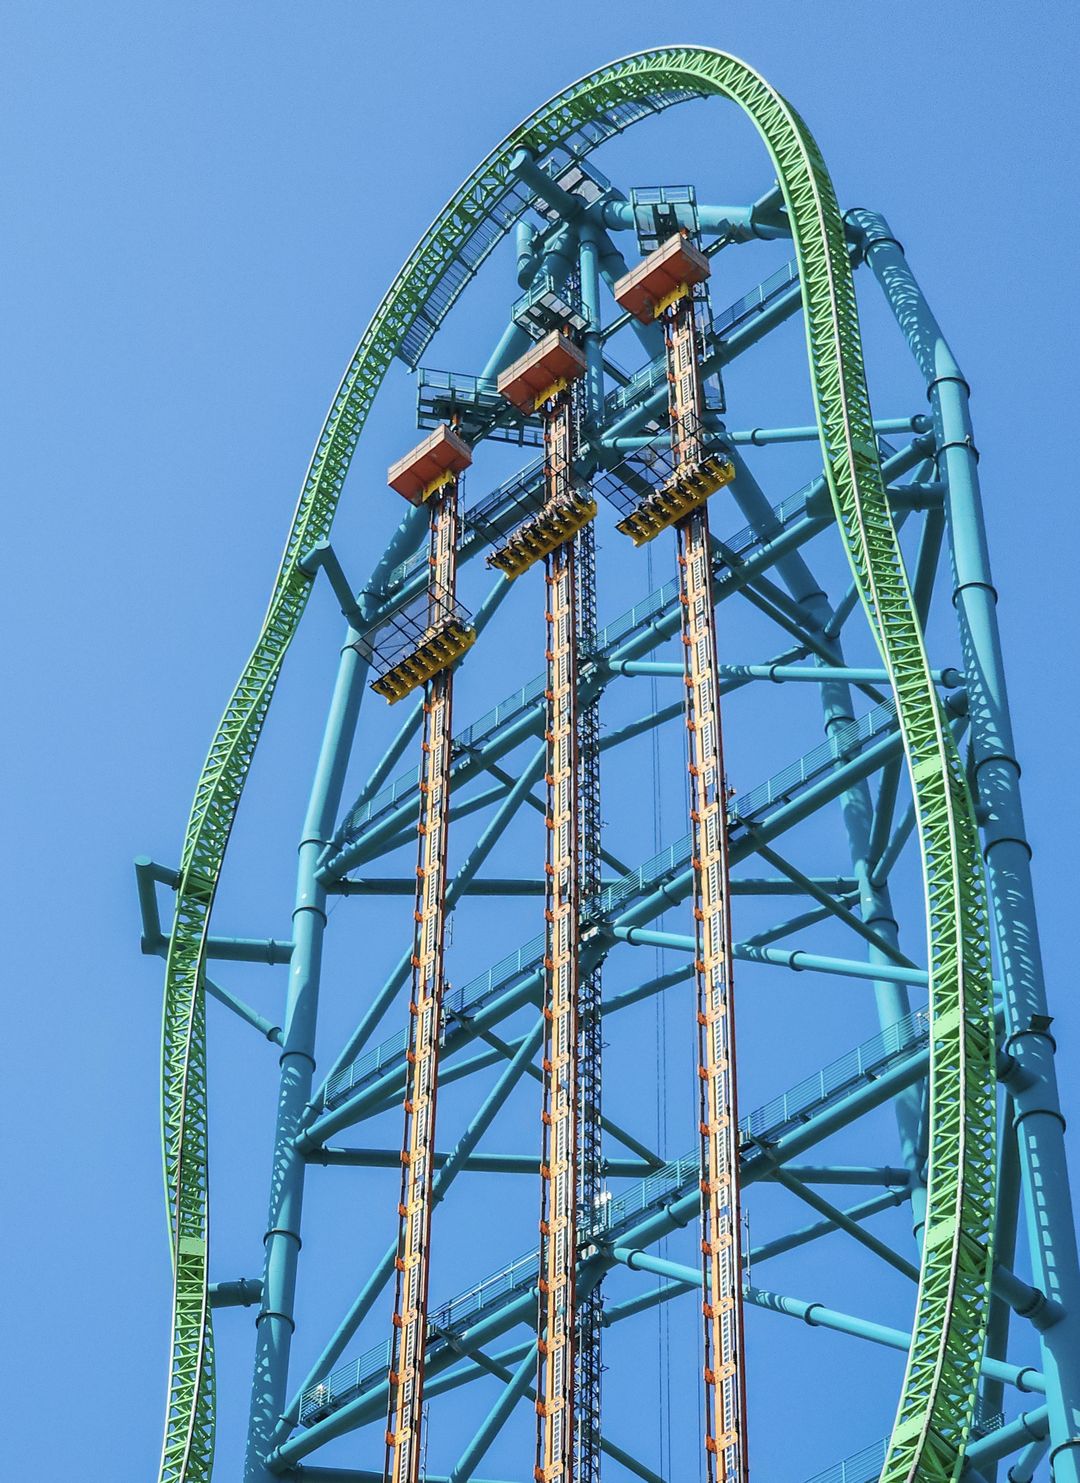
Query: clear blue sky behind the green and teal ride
0 0 1080 1483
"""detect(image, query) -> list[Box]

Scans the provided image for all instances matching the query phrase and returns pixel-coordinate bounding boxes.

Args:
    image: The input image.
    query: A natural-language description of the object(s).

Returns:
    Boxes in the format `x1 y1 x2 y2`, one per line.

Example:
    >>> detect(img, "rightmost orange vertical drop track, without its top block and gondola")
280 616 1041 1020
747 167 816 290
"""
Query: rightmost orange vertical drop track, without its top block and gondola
665 292 748 1483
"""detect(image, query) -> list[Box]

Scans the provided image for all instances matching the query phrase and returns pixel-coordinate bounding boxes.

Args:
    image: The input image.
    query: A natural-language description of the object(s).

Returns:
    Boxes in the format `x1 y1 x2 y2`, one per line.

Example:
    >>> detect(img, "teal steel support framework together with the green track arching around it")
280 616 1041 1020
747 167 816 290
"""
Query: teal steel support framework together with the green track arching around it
138 47 1080 1483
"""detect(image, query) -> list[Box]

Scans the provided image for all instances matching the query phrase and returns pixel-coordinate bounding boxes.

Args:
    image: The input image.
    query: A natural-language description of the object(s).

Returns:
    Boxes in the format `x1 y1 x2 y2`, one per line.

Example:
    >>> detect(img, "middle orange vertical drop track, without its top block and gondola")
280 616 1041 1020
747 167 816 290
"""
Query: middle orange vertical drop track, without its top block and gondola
534 390 580 1483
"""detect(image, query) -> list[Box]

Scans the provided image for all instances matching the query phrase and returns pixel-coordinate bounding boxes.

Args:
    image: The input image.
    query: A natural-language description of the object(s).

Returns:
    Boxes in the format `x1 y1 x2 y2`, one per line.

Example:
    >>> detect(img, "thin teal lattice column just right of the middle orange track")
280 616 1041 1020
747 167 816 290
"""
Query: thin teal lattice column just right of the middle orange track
574 221 604 1483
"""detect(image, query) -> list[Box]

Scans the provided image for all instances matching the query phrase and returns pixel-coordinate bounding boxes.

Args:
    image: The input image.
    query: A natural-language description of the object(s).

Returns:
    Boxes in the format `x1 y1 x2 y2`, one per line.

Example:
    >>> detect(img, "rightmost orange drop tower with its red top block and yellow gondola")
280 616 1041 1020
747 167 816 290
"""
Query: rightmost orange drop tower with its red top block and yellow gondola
613 231 748 1483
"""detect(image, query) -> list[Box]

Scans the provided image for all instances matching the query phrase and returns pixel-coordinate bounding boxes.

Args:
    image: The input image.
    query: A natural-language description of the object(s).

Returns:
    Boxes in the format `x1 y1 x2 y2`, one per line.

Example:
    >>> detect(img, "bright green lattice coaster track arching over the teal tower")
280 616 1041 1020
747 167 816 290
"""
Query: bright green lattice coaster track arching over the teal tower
162 46 995 1483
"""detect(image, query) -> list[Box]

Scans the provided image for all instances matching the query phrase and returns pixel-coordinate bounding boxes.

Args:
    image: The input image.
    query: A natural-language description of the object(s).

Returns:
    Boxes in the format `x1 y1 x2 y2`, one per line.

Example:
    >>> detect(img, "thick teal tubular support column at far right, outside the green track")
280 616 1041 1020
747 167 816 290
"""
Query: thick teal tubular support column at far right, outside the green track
849 211 1080 1483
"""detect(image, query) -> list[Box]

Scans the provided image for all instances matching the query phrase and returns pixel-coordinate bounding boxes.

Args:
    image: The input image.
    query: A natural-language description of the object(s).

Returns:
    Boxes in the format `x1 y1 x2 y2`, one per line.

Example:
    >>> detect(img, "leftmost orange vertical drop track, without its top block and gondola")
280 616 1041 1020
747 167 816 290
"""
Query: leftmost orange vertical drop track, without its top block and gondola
383 475 457 1483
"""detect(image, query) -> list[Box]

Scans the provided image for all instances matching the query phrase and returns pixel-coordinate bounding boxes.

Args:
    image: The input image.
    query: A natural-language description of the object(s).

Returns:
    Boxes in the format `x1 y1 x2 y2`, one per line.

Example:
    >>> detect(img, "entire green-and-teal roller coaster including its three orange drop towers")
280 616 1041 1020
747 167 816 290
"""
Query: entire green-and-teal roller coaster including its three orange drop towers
136 46 1080 1483
